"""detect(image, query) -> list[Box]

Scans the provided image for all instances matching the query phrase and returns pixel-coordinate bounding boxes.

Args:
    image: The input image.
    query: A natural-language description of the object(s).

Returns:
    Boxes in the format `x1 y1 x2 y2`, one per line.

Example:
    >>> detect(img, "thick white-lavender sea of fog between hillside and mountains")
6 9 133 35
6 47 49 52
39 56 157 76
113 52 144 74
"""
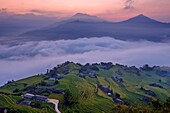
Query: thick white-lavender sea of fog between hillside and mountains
0 37 170 85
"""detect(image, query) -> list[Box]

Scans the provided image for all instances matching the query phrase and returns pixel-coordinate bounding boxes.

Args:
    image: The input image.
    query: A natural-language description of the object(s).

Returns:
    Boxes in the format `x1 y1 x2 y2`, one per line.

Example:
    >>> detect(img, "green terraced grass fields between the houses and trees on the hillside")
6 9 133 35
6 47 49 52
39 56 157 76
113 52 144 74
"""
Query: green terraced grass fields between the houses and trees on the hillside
0 62 170 113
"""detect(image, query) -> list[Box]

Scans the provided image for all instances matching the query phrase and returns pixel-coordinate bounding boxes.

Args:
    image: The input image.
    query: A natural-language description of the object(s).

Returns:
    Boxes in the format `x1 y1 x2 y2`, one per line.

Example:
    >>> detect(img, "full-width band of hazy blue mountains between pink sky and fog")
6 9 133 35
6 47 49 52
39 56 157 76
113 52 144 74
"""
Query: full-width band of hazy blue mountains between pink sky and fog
0 13 170 42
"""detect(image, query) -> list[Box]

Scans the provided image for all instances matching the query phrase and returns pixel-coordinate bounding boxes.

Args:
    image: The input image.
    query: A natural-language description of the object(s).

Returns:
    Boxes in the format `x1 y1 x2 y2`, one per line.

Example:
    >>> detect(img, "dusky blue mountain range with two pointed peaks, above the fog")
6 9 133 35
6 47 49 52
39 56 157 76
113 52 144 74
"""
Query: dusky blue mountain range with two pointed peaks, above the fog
21 13 170 42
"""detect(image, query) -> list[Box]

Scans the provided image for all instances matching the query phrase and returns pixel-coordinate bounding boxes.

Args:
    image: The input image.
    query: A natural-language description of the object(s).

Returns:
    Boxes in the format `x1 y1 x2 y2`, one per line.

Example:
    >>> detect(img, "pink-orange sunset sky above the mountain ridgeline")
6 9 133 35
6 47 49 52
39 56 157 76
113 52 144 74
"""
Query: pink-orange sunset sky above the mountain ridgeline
0 0 170 22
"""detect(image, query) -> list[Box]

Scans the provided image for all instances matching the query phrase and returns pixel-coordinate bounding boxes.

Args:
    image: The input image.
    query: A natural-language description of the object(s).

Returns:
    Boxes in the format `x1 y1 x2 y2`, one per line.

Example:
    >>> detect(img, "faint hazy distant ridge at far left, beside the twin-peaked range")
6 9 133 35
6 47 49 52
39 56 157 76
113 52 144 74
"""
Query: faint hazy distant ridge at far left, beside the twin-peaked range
0 12 57 36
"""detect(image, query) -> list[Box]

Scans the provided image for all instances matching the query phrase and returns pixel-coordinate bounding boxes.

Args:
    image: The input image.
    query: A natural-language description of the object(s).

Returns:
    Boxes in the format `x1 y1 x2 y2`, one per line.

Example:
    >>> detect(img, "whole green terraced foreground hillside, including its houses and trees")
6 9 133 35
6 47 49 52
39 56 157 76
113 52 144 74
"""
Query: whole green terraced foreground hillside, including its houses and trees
0 62 170 113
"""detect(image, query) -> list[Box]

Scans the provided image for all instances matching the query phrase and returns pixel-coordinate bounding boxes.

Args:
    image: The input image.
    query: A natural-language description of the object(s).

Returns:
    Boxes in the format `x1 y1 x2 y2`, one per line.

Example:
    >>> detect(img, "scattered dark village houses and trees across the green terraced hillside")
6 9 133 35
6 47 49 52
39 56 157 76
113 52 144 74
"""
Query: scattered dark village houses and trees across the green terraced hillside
0 62 168 111
